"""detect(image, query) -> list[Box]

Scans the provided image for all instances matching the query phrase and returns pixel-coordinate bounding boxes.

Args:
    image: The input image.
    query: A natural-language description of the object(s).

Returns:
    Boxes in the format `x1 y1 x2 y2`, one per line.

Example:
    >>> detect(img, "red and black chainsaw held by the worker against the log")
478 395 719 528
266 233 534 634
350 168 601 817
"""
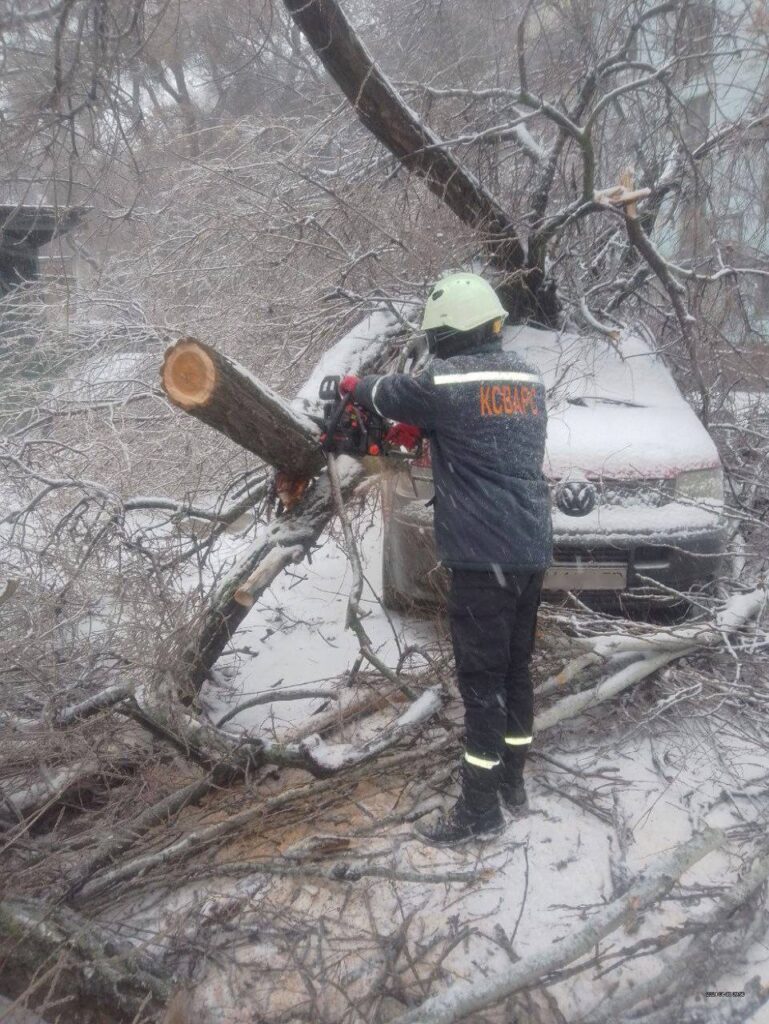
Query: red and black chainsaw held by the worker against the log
318 377 422 459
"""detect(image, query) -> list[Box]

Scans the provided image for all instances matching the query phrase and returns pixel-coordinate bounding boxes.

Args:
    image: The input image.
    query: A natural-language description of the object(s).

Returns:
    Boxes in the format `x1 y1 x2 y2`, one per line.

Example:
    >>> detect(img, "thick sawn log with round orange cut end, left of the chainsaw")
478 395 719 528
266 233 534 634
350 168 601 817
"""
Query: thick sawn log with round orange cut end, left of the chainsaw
161 338 326 479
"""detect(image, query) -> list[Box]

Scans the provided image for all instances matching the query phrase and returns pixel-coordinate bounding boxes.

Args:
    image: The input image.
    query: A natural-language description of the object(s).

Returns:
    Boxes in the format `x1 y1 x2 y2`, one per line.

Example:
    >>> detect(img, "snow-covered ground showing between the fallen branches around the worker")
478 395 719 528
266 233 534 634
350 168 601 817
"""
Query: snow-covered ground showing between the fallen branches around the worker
173 516 769 1024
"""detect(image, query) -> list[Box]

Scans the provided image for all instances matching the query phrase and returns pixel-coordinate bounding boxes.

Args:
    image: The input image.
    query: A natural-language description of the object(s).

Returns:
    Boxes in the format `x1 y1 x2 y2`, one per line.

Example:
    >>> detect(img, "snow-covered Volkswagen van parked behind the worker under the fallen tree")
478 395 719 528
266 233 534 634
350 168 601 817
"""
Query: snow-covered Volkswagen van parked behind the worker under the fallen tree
383 326 725 607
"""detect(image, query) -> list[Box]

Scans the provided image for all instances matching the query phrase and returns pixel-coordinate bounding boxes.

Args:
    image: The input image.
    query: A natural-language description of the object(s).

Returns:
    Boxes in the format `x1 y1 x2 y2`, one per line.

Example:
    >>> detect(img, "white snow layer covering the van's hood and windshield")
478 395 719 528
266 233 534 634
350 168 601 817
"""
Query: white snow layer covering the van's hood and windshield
503 325 720 479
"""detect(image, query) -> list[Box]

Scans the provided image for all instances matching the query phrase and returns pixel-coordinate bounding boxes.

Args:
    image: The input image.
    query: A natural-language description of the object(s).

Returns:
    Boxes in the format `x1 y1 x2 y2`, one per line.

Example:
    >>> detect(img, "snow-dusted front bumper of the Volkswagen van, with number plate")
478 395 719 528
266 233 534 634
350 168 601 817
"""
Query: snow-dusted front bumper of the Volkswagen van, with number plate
385 502 726 602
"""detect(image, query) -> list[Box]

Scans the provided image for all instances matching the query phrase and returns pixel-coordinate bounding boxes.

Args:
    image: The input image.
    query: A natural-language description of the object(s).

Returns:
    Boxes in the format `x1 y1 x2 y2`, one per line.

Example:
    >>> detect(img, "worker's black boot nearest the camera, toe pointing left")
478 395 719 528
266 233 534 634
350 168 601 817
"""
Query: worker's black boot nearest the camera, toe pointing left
417 761 505 846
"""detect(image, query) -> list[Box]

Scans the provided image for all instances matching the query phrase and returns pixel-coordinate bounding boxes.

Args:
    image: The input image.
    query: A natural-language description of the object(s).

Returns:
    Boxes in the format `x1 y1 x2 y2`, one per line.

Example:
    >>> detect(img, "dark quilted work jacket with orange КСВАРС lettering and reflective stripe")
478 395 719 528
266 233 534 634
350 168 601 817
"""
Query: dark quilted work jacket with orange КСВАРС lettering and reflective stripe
355 342 552 572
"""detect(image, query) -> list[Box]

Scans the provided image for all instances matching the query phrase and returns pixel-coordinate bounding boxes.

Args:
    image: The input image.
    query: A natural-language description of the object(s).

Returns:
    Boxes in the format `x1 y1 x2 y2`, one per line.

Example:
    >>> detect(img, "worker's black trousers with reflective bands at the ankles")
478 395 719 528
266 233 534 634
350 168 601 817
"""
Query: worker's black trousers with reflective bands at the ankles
448 569 544 763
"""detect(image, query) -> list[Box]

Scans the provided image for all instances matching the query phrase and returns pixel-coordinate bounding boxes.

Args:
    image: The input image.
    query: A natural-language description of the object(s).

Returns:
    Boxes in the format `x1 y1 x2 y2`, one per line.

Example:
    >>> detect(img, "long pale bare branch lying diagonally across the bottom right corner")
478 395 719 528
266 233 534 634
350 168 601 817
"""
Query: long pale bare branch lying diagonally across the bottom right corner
394 829 726 1024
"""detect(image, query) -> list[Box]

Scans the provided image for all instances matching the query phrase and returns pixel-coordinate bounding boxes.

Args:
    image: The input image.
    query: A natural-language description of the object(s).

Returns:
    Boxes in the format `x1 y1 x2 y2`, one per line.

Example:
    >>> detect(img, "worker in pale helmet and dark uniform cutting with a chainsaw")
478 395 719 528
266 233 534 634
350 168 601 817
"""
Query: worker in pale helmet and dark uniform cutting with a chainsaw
340 273 552 846
